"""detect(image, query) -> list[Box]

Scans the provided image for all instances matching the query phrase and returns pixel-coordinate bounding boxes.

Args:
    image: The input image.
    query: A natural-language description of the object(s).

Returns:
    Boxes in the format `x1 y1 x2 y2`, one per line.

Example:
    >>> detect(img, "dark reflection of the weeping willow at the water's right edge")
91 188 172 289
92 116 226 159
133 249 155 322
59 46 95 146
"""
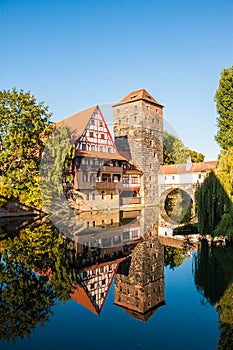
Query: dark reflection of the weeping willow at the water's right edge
194 240 233 350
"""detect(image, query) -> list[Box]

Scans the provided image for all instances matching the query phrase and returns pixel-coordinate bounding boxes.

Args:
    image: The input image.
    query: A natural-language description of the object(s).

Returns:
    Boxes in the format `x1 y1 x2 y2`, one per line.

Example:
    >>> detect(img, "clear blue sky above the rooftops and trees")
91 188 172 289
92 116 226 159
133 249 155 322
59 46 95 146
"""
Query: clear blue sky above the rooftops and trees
0 0 233 160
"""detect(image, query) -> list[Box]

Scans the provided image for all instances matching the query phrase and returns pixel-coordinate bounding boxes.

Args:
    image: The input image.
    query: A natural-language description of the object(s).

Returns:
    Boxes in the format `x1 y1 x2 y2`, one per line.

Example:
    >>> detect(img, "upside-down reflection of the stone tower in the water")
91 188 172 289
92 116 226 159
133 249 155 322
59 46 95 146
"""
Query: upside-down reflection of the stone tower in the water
114 229 164 321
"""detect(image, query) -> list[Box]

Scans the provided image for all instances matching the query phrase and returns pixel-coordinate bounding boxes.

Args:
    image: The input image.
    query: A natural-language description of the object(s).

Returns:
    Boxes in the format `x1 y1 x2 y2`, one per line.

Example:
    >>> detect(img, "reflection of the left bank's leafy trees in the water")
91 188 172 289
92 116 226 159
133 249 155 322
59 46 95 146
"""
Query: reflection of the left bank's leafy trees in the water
0 222 74 342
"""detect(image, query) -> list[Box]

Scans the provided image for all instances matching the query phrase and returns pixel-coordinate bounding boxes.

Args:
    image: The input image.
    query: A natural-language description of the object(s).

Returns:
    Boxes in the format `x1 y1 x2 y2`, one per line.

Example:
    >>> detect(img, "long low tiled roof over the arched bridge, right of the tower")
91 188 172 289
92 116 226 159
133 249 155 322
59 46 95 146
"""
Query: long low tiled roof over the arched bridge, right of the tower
160 160 217 175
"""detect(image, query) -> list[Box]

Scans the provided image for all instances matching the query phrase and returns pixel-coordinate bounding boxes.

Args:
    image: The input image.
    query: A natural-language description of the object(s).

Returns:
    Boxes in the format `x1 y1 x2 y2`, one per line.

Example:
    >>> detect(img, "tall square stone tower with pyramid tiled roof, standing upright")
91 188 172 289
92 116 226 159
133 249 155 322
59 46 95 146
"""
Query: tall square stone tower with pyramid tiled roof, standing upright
113 89 163 205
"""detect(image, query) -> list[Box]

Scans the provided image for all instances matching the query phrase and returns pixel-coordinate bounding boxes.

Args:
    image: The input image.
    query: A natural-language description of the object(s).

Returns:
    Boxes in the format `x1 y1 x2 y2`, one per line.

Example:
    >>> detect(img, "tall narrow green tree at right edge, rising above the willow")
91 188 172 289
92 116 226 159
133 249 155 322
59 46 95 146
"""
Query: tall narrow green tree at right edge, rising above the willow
215 65 233 150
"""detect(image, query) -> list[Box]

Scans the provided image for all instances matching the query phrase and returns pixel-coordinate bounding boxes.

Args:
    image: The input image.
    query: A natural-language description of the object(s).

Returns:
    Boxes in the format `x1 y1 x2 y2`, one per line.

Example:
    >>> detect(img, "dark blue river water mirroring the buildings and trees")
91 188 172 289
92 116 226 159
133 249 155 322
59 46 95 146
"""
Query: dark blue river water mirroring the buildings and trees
0 211 233 350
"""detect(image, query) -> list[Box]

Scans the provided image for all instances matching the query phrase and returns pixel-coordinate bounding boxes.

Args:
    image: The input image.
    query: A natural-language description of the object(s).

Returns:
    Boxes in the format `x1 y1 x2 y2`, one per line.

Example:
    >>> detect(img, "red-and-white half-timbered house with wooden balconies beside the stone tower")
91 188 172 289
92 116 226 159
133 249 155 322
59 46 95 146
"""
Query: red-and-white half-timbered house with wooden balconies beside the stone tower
57 105 142 210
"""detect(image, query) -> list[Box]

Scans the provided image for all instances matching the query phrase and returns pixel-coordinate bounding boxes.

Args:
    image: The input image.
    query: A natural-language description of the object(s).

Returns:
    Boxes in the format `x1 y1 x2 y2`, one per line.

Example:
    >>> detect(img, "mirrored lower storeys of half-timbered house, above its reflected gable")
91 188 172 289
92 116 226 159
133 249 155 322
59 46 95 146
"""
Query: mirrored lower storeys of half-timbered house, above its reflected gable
69 211 141 268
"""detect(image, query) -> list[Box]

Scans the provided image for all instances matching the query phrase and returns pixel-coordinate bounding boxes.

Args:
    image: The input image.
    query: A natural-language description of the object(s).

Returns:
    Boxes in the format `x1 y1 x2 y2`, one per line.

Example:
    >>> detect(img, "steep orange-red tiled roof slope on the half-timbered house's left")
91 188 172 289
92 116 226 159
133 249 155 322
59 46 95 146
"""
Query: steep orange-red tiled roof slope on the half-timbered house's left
56 105 98 140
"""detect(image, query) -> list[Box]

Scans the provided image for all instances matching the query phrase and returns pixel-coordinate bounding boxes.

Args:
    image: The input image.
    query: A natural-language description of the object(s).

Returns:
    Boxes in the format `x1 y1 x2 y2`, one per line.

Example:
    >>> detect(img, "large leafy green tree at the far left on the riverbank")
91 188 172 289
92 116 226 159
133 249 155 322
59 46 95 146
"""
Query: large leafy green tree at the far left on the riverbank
0 88 52 206
